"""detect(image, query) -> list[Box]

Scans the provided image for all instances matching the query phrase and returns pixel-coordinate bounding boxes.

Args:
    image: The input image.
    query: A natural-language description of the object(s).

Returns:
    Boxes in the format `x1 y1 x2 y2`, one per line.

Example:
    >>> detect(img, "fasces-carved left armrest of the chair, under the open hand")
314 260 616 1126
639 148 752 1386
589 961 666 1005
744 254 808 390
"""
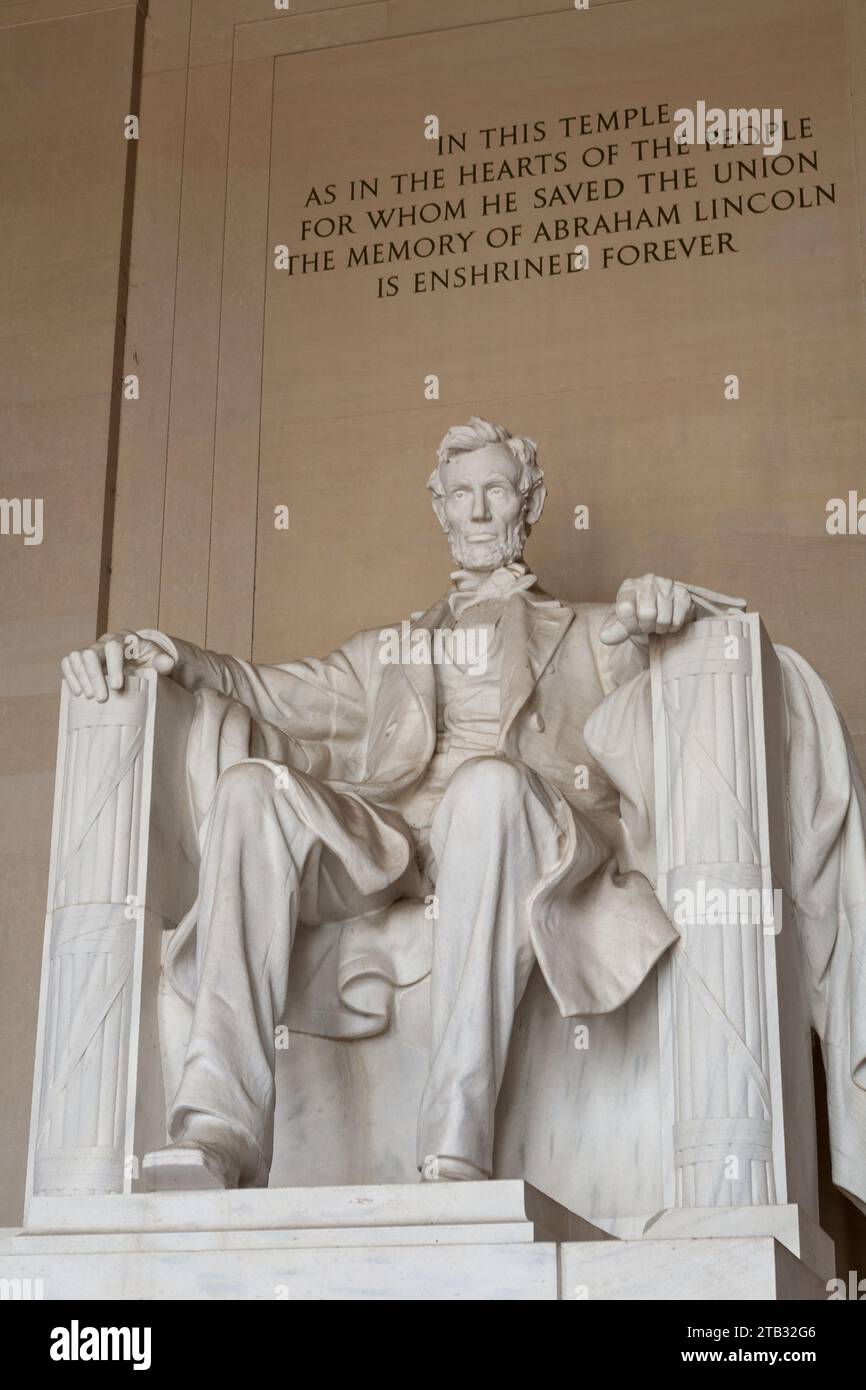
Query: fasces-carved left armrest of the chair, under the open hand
28 671 195 1197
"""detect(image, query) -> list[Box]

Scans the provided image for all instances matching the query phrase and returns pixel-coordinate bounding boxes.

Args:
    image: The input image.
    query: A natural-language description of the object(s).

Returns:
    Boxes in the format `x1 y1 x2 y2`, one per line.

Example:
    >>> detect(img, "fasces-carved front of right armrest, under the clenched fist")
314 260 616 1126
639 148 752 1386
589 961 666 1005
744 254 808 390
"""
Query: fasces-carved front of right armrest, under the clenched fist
651 613 787 1207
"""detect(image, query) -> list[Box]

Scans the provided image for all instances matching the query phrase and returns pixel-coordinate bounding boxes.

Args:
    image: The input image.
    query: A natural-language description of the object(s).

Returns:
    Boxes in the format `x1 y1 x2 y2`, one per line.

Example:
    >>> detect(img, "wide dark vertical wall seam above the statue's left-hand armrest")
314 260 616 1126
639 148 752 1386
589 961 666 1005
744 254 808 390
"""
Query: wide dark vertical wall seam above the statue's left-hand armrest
93 0 147 637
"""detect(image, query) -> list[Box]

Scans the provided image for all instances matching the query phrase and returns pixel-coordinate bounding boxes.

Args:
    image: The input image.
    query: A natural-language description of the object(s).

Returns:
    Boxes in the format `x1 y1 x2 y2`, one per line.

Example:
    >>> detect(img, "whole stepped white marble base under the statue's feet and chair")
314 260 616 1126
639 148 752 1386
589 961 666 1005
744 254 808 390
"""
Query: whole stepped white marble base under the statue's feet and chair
0 1180 826 1301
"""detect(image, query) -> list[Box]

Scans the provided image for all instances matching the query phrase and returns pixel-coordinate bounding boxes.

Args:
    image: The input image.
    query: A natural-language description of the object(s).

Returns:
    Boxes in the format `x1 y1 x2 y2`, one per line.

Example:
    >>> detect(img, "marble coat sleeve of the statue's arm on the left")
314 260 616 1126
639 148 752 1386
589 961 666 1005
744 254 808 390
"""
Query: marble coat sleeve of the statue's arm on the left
139 628 368 744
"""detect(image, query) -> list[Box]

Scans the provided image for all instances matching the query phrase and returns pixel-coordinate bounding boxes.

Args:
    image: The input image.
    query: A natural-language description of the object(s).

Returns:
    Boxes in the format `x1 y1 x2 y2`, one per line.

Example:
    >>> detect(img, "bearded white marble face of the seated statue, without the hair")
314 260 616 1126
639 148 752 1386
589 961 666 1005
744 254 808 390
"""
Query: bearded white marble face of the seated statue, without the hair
436 443 527 570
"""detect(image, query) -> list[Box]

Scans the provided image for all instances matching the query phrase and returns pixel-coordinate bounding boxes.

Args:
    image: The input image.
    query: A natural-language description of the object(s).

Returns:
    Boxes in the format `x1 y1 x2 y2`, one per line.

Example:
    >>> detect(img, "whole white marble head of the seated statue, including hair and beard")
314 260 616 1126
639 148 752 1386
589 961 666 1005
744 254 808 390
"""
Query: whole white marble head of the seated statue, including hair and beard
427 416 548 570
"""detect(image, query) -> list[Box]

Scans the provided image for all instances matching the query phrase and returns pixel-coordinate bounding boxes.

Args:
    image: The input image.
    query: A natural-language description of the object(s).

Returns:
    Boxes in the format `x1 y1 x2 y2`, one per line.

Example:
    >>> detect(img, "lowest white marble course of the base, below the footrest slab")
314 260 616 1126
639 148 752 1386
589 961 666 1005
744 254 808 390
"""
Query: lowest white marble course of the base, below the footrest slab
0 1223 827 1302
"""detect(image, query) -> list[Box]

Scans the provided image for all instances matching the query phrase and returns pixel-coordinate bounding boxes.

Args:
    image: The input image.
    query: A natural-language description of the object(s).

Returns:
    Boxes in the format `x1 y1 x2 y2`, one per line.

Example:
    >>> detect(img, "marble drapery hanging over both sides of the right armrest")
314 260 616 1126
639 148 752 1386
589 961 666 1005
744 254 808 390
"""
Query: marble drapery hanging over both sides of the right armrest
585 646 866 1211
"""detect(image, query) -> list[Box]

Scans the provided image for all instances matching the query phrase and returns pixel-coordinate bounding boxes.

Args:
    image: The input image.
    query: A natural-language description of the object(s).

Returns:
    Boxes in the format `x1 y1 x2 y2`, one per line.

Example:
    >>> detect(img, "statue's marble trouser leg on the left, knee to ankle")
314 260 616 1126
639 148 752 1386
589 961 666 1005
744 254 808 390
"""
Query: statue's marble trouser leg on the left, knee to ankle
168 762 410 1186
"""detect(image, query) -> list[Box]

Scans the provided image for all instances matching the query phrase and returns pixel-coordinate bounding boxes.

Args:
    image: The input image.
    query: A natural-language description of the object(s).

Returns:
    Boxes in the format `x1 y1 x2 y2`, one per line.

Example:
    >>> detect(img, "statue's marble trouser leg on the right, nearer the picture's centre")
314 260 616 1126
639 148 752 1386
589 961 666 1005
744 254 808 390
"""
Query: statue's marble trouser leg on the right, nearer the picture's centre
418 758 598 1176
